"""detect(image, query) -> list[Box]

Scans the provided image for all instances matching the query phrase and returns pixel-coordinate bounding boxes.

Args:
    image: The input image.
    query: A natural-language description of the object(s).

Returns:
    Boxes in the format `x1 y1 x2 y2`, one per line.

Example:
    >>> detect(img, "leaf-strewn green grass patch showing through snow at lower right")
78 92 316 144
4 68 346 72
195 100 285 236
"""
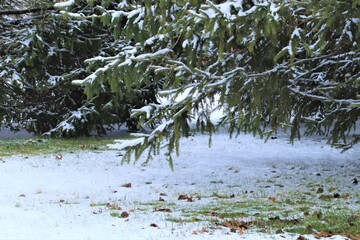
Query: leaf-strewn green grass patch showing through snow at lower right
161 192 360 238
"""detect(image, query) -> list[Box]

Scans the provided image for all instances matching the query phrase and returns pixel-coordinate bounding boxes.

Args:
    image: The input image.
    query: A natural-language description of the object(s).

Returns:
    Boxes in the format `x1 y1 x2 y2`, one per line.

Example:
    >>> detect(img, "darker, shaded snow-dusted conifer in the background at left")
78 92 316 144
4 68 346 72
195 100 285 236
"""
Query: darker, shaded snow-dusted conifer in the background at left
0 0 153 136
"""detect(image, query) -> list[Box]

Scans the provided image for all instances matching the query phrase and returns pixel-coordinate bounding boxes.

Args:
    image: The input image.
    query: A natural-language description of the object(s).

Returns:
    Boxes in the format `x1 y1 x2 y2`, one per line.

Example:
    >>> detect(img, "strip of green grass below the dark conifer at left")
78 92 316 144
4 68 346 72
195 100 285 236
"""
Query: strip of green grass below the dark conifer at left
0 137 120 157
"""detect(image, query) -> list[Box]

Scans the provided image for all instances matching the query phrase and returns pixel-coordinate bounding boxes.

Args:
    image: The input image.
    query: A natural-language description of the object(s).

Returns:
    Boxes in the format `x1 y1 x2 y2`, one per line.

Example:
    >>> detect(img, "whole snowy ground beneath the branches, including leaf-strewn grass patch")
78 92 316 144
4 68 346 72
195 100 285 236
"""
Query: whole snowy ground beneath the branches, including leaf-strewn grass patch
0 132 360 240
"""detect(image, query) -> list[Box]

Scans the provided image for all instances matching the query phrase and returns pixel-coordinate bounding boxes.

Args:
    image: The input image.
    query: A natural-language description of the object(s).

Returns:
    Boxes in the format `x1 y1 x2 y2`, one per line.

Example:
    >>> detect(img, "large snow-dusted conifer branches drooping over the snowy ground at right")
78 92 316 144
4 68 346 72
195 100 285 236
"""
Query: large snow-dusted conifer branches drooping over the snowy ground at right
59 0 360 162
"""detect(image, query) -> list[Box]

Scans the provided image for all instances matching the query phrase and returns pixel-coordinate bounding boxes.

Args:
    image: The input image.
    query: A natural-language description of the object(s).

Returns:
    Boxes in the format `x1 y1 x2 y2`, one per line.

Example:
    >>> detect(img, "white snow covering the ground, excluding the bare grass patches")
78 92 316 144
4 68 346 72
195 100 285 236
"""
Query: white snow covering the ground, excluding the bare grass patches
0 130 360 240
